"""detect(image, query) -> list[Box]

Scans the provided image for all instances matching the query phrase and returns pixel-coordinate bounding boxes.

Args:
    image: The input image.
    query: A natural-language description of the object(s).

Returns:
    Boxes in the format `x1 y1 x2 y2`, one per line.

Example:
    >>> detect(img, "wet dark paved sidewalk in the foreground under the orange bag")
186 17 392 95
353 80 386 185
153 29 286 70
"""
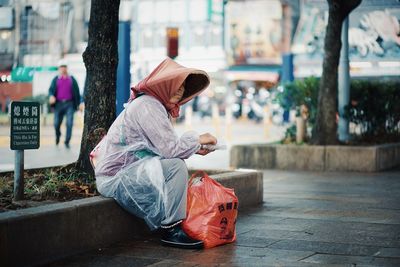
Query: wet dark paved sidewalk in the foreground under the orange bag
43 169 400 267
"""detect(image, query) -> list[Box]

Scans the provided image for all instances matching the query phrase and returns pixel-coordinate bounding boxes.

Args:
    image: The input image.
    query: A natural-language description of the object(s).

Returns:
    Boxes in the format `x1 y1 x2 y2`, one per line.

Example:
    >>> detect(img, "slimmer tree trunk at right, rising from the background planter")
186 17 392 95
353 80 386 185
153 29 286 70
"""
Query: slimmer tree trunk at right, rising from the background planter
312 0 361 145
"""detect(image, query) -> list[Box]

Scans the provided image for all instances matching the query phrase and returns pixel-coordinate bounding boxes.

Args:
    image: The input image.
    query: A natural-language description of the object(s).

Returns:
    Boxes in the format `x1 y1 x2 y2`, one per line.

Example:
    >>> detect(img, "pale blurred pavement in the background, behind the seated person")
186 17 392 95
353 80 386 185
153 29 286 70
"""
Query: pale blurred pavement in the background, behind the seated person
0 118 285 172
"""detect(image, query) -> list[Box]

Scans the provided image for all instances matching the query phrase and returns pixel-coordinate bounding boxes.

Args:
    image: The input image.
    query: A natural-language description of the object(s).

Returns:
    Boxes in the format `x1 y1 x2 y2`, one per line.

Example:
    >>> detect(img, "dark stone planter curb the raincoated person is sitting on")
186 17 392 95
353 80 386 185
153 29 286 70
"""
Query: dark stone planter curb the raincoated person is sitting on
0 171 263 266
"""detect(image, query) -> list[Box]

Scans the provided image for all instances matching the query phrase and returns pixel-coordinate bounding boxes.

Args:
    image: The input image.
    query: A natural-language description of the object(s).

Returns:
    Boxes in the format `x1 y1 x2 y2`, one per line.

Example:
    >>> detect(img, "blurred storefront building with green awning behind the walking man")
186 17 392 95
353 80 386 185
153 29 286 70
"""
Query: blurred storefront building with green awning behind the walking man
0 0 90 111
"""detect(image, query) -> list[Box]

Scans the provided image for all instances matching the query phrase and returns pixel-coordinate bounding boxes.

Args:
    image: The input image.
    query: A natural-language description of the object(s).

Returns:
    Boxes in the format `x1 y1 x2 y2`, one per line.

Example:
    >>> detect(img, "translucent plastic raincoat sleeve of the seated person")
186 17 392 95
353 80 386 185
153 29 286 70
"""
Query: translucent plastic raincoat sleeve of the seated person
137 102 200 159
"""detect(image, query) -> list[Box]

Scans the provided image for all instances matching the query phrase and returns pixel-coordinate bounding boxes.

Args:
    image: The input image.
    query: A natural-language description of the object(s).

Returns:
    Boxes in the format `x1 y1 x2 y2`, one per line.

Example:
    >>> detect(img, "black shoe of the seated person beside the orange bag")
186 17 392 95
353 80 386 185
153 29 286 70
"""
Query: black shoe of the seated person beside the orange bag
161 224 204 249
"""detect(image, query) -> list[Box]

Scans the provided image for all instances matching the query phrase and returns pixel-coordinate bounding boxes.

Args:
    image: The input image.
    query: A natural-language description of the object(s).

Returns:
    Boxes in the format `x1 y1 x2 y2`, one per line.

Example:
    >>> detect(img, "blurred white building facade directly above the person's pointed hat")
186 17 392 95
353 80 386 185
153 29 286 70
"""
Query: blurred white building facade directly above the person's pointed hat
128 0 226 83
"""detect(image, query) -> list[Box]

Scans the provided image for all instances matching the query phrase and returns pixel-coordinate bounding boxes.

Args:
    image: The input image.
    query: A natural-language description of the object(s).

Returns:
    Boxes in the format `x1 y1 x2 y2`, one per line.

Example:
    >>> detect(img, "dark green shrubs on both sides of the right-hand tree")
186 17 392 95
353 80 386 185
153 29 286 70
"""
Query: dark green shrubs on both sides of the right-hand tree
276 77 400 143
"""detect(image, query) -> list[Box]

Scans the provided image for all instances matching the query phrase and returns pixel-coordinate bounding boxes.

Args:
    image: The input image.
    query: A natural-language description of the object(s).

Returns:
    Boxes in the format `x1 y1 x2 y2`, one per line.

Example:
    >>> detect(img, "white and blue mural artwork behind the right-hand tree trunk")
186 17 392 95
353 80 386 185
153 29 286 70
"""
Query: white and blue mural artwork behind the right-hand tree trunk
292 5 400 75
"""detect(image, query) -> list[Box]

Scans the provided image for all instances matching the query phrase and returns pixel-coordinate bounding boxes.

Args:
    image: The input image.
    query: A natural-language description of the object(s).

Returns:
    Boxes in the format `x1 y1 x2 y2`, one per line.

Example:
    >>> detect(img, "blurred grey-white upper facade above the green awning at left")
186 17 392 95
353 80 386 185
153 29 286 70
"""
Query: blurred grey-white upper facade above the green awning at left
0 0 90 69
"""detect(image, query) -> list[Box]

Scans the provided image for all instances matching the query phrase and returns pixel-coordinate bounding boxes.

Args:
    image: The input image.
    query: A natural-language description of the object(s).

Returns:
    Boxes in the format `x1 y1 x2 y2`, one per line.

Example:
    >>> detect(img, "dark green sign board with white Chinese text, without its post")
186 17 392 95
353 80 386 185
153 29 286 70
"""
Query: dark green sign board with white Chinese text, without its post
10 101 40 150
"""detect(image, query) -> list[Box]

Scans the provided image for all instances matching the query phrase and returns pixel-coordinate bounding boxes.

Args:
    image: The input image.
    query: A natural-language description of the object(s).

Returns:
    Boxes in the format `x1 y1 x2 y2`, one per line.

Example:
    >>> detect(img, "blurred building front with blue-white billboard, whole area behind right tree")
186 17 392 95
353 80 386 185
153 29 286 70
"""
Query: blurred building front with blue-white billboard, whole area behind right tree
292 0 400 78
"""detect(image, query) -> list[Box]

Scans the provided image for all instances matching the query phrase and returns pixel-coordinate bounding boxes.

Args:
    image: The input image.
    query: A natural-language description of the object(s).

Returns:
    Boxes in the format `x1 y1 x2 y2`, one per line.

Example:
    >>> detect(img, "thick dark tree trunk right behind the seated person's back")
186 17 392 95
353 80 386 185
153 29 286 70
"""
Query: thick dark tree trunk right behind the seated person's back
76 0 120 174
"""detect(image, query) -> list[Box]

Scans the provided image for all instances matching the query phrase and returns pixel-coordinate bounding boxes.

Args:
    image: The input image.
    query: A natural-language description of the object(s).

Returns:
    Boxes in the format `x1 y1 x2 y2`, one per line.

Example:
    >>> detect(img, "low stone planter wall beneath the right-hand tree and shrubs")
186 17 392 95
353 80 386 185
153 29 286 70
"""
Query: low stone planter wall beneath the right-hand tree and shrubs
230 143 400 172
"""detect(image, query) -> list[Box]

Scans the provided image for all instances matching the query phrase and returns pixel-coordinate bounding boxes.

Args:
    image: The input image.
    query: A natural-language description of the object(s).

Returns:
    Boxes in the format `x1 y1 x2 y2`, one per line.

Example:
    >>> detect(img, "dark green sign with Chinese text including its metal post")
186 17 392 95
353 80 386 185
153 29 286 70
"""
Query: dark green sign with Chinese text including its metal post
10 101 40 200
